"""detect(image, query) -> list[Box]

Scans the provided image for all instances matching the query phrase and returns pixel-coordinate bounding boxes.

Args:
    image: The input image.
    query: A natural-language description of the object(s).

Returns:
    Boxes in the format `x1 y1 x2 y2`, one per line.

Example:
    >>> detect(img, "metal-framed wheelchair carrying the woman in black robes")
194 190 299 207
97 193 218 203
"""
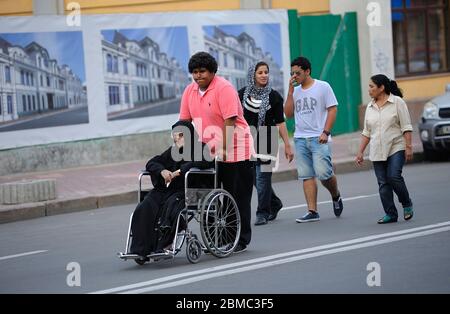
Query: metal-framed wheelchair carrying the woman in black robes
118 159 241 265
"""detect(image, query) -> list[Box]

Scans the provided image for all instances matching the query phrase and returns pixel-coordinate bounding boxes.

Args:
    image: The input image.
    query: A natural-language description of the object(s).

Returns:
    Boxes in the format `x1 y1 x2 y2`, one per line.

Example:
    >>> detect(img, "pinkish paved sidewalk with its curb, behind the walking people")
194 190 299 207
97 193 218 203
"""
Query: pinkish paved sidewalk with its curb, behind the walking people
0 128 422 223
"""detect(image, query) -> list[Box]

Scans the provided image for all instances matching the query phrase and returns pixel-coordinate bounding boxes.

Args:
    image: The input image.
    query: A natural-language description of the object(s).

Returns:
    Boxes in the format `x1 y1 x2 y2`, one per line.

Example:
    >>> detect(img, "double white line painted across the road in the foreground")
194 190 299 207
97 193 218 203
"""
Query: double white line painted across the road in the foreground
92 221 450 294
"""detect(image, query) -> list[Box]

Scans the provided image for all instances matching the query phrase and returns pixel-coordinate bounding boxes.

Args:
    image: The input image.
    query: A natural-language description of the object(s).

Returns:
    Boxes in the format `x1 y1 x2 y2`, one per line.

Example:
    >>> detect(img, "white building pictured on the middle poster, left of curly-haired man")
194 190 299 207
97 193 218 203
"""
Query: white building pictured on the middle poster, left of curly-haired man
102 31 189 113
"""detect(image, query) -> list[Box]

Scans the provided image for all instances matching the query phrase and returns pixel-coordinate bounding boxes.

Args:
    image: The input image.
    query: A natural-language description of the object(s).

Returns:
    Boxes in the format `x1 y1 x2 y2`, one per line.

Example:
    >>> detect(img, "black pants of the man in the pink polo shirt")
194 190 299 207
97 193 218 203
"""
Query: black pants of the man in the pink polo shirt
219 160 254 245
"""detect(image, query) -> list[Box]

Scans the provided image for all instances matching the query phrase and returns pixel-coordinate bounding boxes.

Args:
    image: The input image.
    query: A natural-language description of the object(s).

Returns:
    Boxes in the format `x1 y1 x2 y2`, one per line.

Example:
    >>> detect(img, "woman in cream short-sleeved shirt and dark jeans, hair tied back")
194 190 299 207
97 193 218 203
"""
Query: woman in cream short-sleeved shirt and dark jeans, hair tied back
355 74 414 224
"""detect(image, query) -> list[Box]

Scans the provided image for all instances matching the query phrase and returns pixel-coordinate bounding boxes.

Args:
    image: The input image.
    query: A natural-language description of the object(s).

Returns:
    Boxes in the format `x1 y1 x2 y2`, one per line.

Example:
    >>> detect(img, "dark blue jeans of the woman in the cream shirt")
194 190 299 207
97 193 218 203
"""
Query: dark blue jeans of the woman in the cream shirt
373 150 412 218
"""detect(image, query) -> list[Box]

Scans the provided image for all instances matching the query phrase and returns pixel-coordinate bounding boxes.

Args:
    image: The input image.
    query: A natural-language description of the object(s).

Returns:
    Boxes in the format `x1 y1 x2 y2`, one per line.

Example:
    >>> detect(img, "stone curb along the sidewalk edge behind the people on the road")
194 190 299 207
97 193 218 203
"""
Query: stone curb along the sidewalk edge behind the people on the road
0 152 424 224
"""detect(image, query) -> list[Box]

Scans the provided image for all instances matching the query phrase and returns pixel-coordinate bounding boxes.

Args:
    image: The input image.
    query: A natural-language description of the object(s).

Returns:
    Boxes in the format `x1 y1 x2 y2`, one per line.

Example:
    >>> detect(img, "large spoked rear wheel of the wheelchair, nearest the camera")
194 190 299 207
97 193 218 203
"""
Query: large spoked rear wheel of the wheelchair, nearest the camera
200 189 241 257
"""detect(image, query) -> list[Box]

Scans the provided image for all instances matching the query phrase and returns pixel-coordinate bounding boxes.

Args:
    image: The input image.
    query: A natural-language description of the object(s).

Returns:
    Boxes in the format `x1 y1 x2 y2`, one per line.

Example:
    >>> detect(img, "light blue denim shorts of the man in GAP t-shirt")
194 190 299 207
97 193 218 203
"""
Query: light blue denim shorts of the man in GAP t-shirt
294 137 334 181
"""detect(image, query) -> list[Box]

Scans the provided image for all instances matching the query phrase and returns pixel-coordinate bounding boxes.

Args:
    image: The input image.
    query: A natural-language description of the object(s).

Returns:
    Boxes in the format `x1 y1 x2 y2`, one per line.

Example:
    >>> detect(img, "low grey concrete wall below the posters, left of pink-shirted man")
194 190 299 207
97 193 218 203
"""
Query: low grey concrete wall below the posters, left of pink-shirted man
0 131 172 176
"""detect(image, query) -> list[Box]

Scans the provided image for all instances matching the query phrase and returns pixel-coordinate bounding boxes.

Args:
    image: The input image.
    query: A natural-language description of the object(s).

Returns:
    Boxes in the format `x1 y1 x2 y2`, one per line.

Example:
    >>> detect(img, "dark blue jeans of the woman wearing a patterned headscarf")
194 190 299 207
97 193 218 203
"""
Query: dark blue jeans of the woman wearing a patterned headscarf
255 164 283 219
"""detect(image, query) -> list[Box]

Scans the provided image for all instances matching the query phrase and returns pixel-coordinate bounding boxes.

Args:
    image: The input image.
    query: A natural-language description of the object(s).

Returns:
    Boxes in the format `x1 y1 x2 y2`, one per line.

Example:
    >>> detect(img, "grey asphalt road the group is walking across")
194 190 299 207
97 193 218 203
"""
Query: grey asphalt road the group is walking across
0 162 450 299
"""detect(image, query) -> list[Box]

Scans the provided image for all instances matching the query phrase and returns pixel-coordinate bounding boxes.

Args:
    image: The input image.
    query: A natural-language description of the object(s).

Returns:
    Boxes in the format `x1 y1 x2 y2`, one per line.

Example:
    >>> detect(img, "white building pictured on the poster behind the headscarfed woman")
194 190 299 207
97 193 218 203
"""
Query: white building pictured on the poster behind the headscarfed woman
204 27 284 95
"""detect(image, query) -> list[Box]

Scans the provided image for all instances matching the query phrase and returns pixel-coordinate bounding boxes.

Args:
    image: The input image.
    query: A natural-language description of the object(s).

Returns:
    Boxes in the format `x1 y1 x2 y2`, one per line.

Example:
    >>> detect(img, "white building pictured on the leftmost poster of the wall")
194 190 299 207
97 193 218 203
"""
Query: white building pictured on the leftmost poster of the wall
0 36 87 123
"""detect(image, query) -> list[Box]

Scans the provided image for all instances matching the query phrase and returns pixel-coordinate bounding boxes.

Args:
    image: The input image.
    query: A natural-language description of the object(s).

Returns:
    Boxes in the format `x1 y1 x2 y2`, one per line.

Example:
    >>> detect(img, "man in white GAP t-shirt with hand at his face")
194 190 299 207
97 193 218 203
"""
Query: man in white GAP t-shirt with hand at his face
284 57 344 222
